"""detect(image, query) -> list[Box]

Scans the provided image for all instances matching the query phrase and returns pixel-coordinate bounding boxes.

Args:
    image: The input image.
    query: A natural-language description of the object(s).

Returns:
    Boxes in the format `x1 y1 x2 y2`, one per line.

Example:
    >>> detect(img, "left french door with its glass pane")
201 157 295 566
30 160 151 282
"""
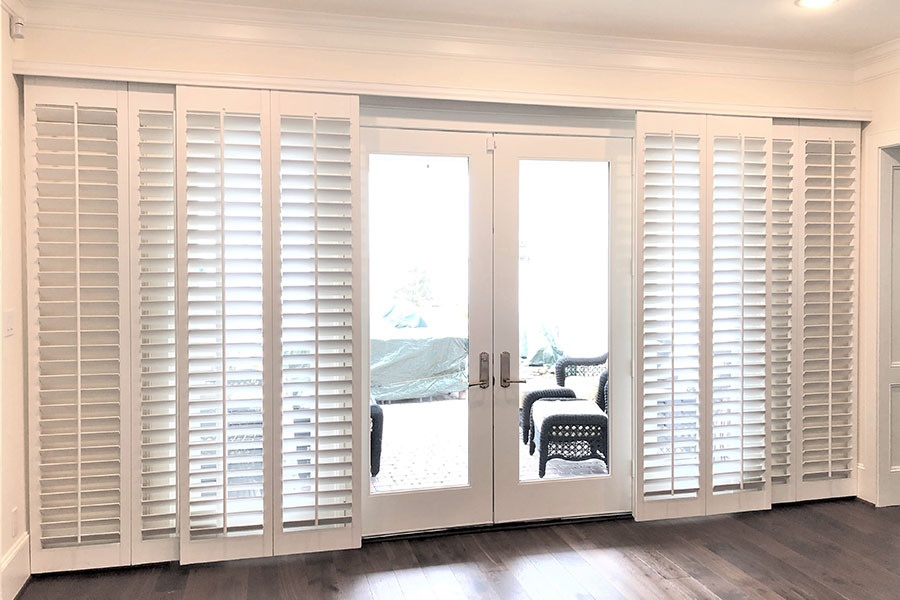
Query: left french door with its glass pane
362 128 492 535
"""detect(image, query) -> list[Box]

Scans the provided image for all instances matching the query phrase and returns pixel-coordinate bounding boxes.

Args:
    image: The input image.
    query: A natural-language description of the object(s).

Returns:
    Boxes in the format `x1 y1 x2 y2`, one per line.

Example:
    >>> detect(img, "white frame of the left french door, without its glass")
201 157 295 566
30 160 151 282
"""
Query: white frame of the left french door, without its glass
360 128 493 536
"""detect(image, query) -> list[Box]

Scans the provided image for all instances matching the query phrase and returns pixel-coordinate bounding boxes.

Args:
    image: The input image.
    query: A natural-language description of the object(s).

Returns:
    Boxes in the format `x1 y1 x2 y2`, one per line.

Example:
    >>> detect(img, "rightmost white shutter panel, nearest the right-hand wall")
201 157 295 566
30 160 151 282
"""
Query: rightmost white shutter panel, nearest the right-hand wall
797 124 859 500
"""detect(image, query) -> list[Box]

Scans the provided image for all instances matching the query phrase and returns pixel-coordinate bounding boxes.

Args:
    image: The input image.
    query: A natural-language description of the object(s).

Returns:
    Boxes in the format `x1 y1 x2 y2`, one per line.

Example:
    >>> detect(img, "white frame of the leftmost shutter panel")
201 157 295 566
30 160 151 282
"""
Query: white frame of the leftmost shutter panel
25 77 131 573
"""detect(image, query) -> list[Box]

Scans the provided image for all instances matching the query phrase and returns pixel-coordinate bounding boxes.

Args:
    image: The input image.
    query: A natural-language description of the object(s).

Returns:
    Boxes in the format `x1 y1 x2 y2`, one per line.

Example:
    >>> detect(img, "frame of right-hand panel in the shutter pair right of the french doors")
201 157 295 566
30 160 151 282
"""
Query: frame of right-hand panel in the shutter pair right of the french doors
705 116 772 514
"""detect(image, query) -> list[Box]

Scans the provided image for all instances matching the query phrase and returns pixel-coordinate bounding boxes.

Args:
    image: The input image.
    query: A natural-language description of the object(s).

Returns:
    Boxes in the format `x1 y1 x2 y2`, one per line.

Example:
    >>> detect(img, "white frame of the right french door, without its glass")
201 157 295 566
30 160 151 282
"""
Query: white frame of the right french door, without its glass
494 135 634 523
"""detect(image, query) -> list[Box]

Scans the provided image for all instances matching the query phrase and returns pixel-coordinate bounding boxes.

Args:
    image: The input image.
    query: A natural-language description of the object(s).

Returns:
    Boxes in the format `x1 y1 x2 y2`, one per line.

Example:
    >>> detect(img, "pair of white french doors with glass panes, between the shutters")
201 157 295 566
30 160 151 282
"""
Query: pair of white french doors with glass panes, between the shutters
362 128 632 535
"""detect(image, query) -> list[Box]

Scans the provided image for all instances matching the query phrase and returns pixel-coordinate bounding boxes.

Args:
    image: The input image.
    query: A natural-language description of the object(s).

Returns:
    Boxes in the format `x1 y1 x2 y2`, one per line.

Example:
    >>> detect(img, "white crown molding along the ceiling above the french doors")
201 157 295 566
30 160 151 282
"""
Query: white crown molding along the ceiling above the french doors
12 0 854 84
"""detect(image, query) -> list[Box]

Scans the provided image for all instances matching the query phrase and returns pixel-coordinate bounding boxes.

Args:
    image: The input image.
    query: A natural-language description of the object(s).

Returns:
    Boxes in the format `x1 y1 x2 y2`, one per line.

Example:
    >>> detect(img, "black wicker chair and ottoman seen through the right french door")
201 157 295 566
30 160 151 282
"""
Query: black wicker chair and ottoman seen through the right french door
522 354 609 477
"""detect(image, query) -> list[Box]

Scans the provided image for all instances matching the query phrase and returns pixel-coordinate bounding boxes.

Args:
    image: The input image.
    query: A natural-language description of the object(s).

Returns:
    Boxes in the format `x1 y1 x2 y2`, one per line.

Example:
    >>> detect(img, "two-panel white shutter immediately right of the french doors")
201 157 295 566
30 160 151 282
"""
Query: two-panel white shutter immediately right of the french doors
635 113 772 520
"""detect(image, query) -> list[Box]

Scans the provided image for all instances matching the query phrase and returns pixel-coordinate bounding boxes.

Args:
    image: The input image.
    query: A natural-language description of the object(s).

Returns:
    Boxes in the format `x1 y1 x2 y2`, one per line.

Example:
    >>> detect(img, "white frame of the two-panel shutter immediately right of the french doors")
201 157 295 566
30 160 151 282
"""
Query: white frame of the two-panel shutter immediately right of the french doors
635 113 772 520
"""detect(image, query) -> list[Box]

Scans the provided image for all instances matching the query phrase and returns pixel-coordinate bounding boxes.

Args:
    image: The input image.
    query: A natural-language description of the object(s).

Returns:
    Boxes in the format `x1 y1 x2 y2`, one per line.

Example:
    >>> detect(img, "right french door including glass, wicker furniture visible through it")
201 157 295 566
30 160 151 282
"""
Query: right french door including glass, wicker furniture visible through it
493 135 633 522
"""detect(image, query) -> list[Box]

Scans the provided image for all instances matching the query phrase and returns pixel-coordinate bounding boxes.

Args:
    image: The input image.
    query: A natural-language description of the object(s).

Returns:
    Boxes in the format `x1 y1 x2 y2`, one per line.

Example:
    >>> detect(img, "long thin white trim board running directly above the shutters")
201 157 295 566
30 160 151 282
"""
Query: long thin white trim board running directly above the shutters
13 60 873 121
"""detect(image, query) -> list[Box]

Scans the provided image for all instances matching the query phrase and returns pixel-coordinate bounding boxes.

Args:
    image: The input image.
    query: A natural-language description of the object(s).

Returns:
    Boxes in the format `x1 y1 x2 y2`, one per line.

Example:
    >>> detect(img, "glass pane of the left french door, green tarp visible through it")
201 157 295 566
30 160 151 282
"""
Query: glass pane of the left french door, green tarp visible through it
369 154 469 493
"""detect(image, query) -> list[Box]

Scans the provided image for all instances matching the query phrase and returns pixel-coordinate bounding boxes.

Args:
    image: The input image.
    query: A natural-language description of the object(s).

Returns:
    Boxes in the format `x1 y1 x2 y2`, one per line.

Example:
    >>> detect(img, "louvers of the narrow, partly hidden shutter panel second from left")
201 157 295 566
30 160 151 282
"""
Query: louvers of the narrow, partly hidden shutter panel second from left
133 106 177 540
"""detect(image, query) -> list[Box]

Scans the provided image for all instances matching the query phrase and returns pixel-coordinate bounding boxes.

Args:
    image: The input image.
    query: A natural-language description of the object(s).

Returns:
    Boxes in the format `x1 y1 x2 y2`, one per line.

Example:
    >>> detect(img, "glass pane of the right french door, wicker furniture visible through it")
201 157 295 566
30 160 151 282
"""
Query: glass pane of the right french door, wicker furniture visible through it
518 160 609 481
